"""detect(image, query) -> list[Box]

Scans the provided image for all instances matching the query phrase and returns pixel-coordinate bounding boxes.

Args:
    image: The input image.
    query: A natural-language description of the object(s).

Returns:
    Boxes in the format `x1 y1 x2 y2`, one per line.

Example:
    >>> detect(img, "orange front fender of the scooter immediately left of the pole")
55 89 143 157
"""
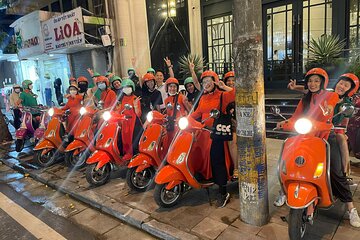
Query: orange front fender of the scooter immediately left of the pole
155 165 186 190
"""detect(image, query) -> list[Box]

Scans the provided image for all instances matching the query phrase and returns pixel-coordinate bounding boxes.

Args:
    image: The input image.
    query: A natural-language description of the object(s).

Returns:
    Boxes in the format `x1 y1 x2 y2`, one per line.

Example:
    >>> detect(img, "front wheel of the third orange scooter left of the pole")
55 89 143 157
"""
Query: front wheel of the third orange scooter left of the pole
85 163 111 187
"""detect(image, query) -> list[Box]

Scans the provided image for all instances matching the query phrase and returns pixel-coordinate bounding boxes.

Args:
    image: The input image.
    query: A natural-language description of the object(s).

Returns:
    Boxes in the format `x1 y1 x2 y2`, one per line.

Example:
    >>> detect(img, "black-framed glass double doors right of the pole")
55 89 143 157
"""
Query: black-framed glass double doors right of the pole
263 0 332 88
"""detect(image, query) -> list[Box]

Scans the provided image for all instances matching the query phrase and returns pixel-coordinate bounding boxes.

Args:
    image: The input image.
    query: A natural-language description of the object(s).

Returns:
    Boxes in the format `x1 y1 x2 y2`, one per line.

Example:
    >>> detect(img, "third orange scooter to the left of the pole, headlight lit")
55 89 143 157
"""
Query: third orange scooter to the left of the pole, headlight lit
86 104 132 186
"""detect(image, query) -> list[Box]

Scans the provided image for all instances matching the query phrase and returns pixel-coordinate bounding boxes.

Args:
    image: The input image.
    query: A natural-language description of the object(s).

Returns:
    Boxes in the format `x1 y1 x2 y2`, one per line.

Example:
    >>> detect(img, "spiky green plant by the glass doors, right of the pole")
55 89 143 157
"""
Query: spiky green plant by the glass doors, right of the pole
308 34 346 66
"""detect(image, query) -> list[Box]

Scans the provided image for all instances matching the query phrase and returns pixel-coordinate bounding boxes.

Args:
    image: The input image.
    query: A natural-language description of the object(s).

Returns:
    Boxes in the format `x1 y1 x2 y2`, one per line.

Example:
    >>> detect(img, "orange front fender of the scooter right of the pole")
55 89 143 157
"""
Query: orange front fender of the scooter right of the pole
287 183 319 209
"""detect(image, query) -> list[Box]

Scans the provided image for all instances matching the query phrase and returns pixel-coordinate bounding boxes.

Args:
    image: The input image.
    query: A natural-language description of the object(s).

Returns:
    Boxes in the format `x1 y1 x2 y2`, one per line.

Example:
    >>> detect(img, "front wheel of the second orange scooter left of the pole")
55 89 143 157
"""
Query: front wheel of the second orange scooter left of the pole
126 167 155 192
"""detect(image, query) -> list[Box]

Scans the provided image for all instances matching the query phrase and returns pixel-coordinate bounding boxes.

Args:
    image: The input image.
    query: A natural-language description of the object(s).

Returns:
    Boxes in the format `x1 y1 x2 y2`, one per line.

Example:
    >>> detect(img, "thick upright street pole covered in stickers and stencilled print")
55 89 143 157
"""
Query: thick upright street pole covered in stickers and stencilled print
233 0 269 226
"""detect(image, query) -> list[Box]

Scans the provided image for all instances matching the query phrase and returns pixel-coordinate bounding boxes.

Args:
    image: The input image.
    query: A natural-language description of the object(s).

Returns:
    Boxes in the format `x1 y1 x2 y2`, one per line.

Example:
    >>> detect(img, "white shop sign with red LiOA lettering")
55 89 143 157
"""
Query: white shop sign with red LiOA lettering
41 7 85 51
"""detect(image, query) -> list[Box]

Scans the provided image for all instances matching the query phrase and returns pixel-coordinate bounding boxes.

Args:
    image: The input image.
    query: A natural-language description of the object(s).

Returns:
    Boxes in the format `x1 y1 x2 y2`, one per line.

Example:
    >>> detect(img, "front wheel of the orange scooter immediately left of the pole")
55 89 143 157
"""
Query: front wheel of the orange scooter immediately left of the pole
154 184 183 208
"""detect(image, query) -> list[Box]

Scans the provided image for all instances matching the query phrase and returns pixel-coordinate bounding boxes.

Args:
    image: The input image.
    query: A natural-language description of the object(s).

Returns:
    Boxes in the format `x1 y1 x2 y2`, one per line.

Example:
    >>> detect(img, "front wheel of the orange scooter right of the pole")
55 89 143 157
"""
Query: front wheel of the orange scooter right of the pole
288 208 307 240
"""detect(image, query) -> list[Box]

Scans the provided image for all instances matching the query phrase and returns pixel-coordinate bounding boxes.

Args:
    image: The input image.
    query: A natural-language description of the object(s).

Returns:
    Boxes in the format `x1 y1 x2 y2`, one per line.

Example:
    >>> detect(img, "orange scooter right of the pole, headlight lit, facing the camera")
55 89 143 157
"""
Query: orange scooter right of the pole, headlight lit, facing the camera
272 105 354 240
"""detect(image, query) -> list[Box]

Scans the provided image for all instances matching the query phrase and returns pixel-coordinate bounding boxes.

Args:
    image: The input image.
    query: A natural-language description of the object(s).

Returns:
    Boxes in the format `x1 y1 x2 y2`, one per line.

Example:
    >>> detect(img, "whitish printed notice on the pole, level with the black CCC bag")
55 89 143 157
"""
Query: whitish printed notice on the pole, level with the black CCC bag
236 107 254 137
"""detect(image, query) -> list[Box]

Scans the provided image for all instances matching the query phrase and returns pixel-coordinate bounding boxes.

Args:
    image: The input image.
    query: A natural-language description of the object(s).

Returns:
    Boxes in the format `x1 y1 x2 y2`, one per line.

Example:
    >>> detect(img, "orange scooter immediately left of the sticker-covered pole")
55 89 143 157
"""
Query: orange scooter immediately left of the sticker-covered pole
154 109 228 208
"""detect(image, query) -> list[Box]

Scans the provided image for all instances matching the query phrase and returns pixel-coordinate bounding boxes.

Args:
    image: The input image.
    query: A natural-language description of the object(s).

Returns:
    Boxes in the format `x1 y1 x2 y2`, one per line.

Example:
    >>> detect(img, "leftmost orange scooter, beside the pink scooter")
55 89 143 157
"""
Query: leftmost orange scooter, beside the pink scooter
34 108 70 167
